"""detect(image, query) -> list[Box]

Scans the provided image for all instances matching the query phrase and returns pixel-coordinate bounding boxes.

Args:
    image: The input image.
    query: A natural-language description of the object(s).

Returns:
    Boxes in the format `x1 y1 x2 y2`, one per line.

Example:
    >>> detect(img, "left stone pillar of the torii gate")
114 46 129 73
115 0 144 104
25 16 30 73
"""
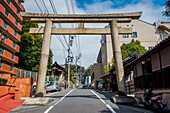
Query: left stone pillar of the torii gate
35 20 52 97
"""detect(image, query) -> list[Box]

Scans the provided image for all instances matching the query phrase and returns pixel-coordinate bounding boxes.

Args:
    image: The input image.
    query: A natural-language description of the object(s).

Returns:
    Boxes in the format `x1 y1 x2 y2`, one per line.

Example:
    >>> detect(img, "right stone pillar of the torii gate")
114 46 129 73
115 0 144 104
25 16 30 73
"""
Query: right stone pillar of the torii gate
110 20 126 94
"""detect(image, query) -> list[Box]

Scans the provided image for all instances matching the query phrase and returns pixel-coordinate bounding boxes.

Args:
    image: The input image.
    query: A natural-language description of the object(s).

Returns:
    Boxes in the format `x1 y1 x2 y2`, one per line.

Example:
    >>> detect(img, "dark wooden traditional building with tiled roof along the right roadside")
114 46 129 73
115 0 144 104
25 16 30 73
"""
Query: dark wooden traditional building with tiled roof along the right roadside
124 37 170 106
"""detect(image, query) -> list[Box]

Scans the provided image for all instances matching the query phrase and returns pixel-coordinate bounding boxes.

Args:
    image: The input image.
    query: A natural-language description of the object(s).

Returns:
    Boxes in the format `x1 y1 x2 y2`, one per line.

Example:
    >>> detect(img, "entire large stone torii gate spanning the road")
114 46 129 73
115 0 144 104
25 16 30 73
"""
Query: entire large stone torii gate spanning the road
22 12 142 97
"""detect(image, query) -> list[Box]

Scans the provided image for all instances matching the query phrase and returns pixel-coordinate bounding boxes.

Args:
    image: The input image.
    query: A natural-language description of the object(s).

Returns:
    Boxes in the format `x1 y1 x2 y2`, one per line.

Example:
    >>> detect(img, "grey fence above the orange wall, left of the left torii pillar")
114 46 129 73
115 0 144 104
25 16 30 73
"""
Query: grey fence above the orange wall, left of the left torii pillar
17 69 38 81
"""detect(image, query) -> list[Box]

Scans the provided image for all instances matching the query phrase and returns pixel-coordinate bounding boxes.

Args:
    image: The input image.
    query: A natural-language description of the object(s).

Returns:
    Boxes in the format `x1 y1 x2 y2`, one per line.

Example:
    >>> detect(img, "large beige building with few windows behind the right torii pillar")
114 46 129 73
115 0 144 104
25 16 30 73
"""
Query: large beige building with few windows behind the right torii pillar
101 19 170 65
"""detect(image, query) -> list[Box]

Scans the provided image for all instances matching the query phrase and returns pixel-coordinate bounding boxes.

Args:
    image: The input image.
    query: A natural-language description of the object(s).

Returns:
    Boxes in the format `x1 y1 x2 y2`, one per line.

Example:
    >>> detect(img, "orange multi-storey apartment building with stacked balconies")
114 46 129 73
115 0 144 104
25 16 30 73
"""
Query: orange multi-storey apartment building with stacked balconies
0 0 24 75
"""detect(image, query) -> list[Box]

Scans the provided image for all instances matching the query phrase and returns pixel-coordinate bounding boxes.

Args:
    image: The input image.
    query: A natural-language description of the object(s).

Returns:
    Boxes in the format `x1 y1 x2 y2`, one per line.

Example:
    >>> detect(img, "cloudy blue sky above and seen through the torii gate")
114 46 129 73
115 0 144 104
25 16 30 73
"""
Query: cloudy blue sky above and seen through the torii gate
24 0 166 67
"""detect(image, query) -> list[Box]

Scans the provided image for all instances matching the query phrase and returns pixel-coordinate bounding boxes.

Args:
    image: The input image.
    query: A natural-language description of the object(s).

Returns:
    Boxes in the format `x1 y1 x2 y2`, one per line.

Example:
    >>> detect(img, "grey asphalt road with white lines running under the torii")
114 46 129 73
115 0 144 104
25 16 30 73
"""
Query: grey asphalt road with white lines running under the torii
14 89 153 113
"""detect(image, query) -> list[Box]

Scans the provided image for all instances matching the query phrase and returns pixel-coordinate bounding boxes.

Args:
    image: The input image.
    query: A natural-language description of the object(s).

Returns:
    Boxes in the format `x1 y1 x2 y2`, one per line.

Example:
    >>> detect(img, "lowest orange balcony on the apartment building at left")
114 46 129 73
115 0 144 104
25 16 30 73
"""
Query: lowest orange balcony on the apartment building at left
0 62 17 75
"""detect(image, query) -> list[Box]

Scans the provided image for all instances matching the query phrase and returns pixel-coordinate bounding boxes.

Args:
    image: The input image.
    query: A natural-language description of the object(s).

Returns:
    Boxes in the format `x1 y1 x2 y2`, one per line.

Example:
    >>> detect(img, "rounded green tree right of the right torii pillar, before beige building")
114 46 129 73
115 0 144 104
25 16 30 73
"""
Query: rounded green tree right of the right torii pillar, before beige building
121 39 147 59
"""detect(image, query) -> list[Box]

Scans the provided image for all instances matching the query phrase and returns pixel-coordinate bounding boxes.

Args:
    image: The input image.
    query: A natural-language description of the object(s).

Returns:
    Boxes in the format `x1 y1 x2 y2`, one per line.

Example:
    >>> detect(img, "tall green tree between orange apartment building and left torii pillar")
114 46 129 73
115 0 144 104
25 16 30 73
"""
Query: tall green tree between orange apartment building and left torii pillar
16 20 53 71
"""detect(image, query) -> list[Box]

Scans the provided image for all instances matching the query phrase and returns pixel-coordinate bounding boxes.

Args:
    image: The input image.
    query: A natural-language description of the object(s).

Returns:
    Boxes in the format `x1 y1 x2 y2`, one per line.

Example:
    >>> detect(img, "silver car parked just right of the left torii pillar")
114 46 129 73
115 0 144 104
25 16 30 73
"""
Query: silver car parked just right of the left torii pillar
46 82 61 92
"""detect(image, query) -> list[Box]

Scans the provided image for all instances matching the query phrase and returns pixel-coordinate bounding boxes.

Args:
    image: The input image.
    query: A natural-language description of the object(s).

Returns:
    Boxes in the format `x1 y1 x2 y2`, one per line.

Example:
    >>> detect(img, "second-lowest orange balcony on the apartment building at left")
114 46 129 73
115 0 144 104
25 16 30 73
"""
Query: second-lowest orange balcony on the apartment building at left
0 48 18 63
